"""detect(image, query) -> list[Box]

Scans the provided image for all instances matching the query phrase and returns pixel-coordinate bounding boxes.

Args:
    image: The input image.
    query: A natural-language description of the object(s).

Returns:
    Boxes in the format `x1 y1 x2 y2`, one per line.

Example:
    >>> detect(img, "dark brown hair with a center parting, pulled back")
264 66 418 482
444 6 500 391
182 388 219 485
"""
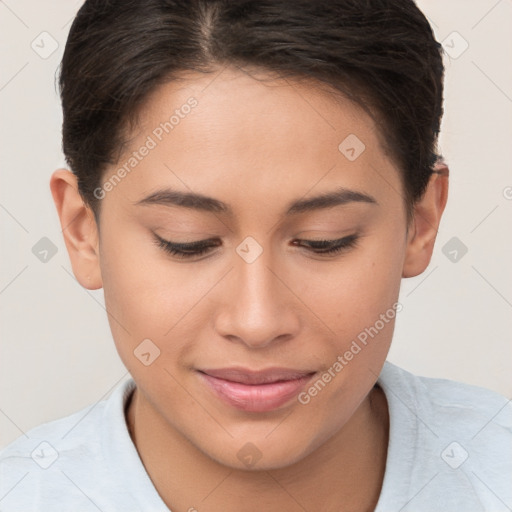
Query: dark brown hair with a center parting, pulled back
59 0 444 218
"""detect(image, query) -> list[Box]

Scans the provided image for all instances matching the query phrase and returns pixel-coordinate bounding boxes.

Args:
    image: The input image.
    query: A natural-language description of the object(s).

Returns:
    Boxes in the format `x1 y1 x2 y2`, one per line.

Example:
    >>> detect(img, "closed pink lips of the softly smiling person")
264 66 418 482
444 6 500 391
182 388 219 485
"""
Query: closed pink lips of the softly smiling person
199 368 314 412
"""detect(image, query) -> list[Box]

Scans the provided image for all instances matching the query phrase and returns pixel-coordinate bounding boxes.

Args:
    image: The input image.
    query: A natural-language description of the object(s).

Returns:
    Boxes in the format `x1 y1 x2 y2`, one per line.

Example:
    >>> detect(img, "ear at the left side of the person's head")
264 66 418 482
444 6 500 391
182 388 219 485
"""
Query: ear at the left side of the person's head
50 169 103 290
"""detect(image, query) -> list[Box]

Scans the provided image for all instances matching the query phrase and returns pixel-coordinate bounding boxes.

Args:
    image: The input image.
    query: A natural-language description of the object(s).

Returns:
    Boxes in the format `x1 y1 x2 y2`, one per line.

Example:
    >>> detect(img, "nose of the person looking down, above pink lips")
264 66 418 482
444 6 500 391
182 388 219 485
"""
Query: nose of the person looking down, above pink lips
215 246 301 348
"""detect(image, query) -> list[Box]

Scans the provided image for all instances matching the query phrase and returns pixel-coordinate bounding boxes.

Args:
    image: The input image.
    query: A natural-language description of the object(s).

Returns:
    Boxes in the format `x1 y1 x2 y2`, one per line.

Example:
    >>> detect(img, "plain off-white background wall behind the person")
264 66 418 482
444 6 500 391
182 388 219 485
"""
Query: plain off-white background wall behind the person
0 0 512 448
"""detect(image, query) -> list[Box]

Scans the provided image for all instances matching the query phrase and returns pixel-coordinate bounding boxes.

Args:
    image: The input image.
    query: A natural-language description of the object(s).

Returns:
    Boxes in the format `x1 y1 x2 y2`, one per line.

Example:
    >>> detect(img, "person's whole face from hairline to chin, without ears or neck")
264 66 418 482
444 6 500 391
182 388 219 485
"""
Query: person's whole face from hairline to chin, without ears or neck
53 68 444 468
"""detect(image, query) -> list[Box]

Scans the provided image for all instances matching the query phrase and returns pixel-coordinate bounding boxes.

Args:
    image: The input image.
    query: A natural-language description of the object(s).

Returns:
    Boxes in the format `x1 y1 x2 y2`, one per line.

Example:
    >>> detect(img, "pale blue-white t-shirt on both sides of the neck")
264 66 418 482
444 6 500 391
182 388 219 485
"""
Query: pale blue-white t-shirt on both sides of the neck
0 362 512 512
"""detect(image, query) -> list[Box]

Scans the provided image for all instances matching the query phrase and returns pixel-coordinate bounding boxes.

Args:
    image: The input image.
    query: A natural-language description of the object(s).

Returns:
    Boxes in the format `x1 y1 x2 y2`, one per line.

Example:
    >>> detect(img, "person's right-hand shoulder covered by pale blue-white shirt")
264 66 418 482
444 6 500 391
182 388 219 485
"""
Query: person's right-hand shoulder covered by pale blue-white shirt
378 362 512 511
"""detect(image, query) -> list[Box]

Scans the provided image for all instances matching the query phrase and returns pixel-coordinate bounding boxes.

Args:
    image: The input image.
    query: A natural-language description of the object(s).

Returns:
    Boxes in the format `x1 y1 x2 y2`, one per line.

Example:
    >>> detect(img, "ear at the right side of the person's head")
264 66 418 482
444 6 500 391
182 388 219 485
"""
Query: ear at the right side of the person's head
402 160 449 277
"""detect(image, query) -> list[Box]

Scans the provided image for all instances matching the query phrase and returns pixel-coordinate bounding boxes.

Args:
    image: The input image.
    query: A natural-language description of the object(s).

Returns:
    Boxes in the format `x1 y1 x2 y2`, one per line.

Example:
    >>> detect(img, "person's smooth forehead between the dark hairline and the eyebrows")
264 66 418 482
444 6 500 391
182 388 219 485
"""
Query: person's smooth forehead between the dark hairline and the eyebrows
105 67 400 214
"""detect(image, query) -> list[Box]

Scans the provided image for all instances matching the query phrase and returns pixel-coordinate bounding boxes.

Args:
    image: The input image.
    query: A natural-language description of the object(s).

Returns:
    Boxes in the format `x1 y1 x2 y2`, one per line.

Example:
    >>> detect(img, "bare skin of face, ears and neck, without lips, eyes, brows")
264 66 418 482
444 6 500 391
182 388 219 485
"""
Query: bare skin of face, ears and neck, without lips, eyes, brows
51 67 448 512
